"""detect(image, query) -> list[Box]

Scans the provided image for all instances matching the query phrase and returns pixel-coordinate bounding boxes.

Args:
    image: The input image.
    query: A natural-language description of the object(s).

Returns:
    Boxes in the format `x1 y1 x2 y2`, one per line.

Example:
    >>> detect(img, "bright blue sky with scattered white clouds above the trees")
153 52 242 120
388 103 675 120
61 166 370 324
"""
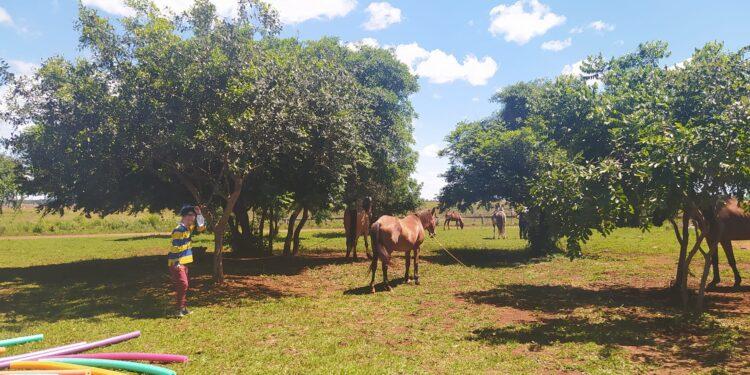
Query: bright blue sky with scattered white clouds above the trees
0 0 750 198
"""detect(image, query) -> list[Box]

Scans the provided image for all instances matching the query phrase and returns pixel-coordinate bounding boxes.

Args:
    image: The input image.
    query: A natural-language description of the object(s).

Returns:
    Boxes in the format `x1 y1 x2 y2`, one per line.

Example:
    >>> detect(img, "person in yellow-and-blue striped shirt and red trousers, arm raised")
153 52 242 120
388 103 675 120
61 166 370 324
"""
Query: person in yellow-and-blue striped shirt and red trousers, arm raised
168 205 206 317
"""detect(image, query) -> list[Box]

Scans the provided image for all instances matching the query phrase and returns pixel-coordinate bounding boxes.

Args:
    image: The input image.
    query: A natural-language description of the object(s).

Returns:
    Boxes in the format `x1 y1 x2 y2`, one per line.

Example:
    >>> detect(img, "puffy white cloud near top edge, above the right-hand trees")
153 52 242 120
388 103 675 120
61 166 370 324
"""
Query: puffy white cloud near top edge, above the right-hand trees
489 0 565 45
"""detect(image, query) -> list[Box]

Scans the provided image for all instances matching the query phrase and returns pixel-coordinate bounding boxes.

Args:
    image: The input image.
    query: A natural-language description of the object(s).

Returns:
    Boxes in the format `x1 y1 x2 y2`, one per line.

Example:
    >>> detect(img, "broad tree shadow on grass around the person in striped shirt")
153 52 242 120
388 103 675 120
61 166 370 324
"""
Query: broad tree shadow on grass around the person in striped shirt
0 255 352 325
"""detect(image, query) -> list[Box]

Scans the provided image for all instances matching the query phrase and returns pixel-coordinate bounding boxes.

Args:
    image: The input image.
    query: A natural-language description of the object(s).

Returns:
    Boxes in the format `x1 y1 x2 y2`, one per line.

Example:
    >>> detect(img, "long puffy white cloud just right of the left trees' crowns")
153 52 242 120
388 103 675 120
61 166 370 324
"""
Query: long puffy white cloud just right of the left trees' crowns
395 43 497 86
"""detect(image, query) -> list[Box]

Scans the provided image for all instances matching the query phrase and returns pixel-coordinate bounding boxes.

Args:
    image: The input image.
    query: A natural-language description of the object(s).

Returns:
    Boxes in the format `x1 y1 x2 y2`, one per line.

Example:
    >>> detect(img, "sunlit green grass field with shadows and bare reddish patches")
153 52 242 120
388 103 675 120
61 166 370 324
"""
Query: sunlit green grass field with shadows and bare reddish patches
0 227 750 374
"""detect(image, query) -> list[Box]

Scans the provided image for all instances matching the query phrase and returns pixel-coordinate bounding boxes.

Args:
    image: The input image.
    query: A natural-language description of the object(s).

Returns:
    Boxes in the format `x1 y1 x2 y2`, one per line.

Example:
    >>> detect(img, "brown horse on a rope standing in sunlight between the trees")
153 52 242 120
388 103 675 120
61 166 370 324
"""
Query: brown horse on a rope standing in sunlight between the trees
370 208 435 293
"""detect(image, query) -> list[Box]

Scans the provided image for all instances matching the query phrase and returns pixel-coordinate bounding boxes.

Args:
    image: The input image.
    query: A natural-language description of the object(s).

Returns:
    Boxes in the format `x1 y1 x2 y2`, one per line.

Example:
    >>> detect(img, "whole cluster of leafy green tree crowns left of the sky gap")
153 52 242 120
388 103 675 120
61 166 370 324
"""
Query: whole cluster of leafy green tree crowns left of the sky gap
6 0 419 281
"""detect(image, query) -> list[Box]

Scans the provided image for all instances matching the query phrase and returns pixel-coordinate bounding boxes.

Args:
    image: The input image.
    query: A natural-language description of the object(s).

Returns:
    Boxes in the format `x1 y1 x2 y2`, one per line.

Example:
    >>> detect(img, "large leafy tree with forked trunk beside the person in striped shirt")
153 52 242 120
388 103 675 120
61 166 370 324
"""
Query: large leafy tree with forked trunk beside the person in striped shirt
2 1 366 282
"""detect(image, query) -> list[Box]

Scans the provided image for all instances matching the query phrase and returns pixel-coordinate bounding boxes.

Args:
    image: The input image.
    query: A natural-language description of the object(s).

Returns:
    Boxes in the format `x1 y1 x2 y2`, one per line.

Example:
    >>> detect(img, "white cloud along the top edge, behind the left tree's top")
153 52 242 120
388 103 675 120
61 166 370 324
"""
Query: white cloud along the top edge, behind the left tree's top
83 0 357 24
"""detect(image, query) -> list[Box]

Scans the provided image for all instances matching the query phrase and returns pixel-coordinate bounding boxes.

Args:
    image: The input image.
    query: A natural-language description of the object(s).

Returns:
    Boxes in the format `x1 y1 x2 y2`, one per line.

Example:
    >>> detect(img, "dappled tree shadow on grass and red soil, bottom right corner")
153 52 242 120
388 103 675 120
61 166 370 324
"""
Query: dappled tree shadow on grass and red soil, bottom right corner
458 284 750 368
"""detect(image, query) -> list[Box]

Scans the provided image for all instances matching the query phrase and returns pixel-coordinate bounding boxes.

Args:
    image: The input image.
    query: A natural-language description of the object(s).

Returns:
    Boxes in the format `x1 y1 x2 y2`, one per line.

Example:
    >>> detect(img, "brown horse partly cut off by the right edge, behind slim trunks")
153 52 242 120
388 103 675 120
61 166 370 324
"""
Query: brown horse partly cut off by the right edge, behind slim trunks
706 198 750 287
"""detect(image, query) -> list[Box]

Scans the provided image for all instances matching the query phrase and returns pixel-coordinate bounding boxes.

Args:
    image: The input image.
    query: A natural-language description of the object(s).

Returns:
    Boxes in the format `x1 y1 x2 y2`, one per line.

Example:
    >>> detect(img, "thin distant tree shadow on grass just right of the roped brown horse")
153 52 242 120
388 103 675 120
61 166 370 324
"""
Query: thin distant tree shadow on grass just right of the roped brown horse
420 249 548 268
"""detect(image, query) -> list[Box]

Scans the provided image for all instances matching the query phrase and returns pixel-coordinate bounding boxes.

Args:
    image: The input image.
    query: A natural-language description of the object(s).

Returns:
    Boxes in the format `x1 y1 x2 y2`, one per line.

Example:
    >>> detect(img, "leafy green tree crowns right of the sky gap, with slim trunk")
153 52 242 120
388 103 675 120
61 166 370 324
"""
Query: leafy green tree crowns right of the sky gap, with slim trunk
441 41 750 306
